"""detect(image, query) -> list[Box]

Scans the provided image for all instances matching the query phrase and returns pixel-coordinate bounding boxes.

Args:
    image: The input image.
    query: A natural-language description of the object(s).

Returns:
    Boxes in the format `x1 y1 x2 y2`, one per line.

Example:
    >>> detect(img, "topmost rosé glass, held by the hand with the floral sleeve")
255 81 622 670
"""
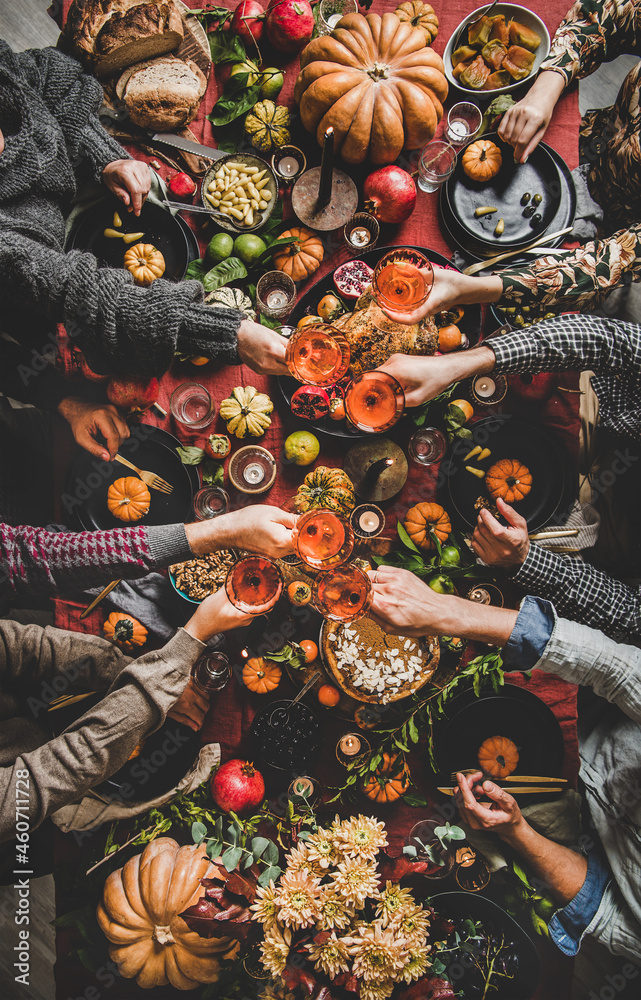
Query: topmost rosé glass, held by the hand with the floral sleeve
372 247 434 313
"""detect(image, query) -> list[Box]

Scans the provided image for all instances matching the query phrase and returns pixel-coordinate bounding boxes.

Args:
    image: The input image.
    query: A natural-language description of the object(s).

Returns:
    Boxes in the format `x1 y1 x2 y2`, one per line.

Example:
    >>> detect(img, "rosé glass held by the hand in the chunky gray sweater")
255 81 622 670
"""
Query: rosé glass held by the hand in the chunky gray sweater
285 323 350 386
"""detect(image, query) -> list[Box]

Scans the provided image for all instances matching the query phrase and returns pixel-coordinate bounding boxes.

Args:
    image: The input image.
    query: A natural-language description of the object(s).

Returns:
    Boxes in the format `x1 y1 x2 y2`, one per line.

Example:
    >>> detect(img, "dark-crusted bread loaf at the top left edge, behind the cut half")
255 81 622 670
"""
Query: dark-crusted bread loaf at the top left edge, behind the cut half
64 0 183 79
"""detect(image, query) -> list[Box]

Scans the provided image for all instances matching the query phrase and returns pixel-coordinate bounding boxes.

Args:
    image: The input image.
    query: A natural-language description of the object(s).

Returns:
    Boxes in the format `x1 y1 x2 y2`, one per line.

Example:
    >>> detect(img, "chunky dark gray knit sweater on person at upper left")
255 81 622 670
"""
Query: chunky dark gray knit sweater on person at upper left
0 40 242 376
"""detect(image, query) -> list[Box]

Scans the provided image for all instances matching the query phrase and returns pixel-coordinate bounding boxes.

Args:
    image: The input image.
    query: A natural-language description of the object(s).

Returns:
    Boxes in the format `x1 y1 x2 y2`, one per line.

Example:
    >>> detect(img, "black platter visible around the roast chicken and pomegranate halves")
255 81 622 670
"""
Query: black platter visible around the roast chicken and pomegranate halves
278 246 481 441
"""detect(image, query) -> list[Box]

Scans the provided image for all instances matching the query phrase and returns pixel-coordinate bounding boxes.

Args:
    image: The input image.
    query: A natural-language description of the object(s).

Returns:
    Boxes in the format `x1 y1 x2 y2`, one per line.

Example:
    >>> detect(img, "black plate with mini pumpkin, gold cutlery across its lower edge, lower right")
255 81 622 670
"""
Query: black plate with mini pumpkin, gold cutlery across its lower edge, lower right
435 684 564 786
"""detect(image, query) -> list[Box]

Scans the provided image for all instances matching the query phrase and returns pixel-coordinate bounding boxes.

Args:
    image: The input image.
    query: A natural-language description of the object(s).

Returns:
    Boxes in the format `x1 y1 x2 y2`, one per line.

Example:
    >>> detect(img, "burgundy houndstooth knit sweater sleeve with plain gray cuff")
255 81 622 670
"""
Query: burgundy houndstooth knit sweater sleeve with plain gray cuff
0 524 193 598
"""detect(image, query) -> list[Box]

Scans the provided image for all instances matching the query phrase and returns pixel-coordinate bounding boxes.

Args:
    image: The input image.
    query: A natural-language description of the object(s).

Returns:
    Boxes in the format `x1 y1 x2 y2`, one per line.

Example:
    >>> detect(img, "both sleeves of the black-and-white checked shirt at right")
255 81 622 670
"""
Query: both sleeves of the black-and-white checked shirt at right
487 315 641 643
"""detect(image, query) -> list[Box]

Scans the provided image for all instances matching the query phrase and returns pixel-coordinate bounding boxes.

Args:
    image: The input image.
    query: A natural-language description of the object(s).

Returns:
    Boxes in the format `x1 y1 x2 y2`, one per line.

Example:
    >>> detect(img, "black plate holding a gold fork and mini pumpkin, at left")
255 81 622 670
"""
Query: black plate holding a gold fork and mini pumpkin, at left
63 424 199 531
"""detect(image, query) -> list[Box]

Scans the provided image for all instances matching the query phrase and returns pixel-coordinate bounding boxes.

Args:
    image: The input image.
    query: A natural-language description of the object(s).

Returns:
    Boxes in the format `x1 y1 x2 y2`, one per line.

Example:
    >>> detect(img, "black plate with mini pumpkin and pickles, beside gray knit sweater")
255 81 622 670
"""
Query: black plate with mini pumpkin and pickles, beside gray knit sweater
70 198 194 281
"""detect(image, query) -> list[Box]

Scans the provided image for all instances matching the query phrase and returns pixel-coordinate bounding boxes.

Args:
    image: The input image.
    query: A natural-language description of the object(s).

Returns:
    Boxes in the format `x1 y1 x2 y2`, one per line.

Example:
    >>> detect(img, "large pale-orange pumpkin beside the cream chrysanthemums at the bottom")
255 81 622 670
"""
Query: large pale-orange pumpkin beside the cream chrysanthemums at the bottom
96 837 233 990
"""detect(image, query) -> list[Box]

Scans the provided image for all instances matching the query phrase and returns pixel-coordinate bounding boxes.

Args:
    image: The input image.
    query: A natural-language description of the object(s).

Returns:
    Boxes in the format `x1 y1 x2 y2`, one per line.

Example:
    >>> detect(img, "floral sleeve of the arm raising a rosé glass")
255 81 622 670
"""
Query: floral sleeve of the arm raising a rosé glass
500 222 641 312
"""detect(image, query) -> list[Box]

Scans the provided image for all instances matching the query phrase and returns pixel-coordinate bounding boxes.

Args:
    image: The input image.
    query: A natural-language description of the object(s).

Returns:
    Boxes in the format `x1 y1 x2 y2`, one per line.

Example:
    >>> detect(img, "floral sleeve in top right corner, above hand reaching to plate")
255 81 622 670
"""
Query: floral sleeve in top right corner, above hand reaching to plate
541 0 641 83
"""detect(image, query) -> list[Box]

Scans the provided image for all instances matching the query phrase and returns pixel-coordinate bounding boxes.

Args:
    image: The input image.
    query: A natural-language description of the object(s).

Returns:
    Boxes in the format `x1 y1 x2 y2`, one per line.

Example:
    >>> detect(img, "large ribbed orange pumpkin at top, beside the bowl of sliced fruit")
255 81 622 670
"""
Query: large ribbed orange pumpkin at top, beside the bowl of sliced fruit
294 13 447 164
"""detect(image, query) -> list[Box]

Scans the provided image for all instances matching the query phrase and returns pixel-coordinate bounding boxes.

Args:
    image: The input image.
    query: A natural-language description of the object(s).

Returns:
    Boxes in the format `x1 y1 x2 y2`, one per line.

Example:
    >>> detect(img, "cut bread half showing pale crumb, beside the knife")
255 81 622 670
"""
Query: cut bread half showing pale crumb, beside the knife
116 56 207 132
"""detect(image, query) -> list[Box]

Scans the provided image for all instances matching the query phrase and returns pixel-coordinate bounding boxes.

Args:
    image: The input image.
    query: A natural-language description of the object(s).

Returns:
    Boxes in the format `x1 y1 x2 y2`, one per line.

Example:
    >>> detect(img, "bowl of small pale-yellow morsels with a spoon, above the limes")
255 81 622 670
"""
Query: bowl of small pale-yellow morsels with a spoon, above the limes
200 153 278 233
